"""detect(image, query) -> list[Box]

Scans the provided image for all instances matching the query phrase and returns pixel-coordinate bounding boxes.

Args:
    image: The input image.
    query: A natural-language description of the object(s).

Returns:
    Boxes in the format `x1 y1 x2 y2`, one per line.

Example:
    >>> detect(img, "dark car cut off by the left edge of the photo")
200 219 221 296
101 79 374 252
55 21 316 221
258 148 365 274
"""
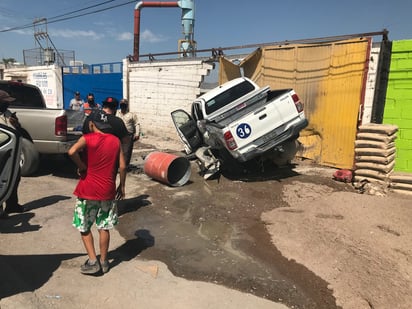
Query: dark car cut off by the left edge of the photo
0 124 22 205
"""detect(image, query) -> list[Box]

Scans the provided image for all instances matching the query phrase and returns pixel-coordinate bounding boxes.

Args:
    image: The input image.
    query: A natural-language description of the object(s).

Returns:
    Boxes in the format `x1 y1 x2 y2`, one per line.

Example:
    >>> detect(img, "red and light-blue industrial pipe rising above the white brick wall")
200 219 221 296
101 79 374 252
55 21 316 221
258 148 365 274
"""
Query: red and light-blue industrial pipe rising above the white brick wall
133 0 195 61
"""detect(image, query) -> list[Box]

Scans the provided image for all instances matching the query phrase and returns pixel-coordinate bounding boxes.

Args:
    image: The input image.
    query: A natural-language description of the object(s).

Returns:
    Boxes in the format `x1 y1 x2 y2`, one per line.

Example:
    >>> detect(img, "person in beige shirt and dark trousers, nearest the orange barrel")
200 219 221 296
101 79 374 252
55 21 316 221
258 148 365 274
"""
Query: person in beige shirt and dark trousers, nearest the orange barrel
117 99 140 168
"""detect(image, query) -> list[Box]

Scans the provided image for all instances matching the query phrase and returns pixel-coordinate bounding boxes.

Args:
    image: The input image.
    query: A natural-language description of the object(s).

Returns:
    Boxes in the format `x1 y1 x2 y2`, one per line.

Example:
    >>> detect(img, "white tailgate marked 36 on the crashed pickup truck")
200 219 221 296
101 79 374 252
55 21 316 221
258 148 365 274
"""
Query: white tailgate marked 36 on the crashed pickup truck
229 93 299 148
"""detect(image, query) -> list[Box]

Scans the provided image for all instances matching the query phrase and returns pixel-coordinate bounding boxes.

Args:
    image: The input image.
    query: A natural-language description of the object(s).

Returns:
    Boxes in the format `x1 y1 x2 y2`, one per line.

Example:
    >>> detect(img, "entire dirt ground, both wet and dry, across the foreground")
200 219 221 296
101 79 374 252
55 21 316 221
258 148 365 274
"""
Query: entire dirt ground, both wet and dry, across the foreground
0 135 412 309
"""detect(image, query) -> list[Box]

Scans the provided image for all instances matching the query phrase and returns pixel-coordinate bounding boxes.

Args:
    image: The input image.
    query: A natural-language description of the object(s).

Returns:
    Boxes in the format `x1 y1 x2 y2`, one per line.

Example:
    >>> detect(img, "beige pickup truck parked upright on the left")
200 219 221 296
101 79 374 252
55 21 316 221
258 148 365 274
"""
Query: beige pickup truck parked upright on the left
0 80 84 176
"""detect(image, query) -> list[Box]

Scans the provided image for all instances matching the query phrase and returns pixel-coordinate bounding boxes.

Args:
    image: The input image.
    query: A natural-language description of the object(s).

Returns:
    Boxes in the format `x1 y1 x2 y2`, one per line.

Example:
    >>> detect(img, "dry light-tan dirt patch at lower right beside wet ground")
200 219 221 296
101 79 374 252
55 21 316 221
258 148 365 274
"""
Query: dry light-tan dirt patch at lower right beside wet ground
262 172 412 309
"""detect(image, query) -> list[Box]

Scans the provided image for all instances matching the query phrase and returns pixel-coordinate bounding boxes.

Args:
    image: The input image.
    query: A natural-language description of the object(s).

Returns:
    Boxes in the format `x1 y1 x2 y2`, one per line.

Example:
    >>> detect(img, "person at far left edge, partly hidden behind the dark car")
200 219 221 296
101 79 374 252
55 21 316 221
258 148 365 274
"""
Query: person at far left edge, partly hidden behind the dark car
0 90 25 218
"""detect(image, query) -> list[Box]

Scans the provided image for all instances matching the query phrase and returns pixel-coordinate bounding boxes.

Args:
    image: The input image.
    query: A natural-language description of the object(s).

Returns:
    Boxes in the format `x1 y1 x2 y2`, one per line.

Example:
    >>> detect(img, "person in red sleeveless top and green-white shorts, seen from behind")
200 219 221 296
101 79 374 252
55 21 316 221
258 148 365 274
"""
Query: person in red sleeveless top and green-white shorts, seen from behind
68 110 126 274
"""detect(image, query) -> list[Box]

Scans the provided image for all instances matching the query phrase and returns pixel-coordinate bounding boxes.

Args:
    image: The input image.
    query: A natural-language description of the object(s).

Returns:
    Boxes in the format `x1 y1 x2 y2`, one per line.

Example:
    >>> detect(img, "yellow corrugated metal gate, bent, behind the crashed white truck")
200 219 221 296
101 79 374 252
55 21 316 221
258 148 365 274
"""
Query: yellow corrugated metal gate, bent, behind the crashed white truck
220 38 371 168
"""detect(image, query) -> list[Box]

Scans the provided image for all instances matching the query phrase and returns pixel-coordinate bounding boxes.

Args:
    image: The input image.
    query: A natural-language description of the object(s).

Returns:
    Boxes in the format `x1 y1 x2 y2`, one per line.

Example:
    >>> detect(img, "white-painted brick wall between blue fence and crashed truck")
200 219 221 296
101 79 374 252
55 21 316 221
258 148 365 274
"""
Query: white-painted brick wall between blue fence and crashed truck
123 60 213 140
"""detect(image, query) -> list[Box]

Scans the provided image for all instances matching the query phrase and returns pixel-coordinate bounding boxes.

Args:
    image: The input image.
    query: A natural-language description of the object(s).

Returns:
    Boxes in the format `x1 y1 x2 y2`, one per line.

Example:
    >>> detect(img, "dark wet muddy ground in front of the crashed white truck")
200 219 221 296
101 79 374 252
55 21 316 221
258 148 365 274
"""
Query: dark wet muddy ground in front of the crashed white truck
119 142 354 309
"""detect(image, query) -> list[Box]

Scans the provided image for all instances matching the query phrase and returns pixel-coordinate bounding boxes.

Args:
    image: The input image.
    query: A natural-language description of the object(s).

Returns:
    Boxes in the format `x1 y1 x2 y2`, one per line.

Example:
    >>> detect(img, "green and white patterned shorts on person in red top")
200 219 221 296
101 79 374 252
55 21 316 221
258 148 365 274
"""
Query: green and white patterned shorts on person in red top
73 198 118 232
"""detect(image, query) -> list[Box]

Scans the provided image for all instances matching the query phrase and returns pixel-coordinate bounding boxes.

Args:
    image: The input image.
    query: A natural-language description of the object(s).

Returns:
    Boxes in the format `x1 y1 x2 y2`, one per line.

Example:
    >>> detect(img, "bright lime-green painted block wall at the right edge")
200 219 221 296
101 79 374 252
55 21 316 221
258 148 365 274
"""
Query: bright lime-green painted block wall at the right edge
383 40 412 173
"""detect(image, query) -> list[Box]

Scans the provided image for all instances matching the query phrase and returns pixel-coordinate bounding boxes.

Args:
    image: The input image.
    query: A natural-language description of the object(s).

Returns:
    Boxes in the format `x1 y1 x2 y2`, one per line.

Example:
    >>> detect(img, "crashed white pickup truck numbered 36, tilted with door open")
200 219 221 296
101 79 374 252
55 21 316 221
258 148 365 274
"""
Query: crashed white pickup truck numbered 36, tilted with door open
171 77 308 178
